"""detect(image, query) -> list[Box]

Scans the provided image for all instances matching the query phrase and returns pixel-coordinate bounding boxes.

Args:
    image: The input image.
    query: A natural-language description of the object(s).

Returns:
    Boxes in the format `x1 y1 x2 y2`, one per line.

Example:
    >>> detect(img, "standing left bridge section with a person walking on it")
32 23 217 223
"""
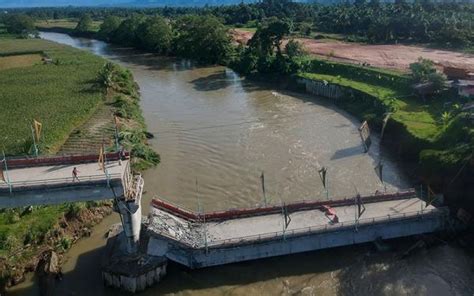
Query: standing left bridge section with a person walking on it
0 156 131 208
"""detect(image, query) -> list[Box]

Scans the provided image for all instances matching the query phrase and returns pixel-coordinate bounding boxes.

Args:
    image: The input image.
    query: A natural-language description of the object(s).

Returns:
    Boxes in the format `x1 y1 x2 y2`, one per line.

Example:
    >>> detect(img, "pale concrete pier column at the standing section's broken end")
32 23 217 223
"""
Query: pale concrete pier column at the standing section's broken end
117 200 142 254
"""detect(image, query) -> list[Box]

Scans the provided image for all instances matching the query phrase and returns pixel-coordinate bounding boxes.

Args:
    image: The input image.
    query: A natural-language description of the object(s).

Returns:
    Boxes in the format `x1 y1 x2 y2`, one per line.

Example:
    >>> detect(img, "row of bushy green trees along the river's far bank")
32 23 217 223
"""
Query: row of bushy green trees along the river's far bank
94 15 304 74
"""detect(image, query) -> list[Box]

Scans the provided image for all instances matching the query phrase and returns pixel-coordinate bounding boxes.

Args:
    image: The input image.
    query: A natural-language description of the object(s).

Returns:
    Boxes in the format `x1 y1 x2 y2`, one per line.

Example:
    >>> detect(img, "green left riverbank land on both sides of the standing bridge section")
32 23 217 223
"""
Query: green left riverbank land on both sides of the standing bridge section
0 38 159 289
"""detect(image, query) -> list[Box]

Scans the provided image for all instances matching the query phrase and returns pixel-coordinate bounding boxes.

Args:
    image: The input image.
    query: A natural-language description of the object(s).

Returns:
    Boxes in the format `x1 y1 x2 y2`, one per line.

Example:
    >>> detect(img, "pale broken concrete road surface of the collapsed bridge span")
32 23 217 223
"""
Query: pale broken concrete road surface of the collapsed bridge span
149 198 436 248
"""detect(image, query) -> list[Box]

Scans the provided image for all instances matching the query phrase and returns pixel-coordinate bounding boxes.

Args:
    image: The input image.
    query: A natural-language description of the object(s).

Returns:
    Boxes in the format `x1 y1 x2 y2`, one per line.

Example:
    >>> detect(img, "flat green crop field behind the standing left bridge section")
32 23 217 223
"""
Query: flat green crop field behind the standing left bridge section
0 39 104 155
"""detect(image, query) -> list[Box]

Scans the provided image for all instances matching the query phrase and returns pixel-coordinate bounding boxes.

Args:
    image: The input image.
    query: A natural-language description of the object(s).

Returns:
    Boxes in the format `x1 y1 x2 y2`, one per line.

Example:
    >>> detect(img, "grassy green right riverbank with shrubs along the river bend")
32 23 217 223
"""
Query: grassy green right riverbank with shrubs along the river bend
294 60 474 211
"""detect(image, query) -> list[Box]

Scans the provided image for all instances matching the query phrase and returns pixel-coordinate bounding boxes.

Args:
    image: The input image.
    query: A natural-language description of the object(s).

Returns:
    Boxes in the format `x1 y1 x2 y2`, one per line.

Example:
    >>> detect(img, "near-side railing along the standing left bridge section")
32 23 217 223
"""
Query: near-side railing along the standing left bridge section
0 173 122 192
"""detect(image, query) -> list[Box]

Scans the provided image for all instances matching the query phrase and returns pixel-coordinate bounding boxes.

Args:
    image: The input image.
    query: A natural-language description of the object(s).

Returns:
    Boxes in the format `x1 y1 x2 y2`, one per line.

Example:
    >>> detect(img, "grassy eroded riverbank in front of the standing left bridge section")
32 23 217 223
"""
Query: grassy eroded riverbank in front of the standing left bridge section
0 202 113 292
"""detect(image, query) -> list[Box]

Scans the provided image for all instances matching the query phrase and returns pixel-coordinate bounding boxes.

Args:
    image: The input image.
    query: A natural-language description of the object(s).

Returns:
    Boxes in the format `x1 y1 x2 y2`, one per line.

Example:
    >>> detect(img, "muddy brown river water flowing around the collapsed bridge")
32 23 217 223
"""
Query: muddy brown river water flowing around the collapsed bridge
7 33 474 295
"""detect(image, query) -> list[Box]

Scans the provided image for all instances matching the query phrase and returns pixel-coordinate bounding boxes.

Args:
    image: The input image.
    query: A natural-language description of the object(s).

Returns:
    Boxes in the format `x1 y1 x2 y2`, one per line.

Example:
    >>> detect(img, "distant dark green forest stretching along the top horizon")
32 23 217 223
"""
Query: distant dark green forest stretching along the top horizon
6 0 474 47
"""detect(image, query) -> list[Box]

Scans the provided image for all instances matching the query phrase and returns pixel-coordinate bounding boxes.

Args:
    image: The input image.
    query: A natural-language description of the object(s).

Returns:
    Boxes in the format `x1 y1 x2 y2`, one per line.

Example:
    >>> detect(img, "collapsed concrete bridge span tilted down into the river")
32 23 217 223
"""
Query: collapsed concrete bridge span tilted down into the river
148 195 448 268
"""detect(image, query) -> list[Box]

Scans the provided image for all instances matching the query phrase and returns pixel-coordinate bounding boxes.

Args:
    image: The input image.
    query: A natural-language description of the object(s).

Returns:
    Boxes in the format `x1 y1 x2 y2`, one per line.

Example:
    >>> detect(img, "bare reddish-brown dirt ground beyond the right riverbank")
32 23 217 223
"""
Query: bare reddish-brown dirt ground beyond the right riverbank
231 29 474 71
